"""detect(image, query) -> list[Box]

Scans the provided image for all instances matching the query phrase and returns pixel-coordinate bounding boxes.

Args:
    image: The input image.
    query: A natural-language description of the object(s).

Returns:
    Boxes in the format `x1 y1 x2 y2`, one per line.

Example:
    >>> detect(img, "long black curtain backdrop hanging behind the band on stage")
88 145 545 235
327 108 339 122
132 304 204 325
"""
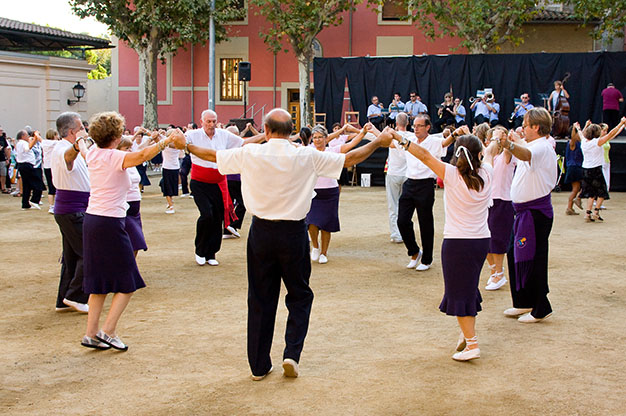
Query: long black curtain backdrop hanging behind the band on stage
314 52 626 130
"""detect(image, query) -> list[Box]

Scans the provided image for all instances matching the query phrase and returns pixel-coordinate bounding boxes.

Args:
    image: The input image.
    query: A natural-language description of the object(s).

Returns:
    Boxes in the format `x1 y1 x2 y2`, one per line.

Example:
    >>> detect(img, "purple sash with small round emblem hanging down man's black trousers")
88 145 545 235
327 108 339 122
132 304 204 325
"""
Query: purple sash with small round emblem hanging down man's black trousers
513 194 554 291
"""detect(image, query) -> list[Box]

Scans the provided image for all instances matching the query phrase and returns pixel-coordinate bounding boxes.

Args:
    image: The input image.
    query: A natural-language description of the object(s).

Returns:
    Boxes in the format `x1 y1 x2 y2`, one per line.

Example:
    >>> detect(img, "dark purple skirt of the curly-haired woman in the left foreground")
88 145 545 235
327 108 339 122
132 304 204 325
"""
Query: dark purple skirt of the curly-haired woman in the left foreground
83 214 146 294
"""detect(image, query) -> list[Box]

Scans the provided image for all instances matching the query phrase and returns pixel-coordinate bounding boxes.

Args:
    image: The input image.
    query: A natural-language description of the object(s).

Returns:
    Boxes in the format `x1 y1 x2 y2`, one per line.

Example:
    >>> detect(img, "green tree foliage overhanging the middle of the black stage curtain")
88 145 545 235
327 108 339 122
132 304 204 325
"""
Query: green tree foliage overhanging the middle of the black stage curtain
394 0 537 53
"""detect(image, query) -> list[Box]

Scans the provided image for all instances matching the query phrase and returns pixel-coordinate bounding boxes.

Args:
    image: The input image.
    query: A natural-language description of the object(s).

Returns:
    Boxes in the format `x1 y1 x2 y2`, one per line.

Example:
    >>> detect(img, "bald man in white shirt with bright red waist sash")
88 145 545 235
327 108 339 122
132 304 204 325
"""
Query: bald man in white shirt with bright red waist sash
185 110 264 266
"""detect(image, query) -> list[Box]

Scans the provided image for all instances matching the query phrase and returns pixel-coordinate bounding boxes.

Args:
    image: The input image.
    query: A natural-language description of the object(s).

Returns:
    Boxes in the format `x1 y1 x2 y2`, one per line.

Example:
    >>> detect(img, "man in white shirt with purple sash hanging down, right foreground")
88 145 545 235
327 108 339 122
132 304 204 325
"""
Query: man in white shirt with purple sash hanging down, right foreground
500 108 557 323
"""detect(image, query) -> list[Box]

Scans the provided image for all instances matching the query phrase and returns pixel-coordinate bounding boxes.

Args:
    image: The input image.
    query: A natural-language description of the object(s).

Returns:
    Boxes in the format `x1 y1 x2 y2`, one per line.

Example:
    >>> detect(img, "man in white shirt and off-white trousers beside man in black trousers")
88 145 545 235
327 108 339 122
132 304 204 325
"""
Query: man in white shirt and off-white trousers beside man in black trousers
385 113 412 243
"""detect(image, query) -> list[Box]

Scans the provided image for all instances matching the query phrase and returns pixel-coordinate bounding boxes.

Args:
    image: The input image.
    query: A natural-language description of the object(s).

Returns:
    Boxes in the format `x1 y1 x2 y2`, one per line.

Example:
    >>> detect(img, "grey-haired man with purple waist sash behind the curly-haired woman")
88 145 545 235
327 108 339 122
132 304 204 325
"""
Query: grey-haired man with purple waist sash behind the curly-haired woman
50 112 91 313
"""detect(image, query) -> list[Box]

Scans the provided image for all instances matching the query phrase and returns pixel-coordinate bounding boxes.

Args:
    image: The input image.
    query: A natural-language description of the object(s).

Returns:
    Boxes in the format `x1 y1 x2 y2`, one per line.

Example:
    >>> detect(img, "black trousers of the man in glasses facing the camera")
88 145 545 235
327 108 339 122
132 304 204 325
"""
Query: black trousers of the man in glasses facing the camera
398 178 435 264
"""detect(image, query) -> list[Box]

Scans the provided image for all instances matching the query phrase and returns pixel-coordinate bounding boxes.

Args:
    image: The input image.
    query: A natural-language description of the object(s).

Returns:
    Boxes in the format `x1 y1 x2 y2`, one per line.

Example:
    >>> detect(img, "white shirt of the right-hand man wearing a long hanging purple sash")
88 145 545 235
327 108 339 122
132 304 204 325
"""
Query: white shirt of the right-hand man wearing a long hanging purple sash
511 137 557 204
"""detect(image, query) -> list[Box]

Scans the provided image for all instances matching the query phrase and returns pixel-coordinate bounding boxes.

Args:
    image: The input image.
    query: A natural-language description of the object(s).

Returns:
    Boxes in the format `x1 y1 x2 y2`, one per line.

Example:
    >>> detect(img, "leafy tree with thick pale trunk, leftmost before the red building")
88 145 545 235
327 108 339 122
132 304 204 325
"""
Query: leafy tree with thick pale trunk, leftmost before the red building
70 0 243 128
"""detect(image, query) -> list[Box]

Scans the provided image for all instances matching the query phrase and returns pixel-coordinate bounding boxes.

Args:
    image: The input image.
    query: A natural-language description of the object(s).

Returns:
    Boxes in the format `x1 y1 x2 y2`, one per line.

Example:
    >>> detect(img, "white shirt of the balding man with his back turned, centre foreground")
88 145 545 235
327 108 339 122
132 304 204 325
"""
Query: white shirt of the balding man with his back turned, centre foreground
217 139 345 221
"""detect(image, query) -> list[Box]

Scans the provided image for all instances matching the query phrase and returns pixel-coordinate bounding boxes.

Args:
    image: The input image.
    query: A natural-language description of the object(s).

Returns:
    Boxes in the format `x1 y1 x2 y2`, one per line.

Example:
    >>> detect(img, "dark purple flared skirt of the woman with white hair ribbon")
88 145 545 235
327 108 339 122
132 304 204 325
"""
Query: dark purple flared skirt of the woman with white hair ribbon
439 238 489 316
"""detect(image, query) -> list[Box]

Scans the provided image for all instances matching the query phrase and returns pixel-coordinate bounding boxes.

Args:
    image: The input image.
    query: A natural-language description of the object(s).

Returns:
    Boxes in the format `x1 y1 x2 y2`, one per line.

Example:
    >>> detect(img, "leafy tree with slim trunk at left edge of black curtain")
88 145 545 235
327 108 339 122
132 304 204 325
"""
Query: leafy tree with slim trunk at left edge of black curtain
251 0 360 125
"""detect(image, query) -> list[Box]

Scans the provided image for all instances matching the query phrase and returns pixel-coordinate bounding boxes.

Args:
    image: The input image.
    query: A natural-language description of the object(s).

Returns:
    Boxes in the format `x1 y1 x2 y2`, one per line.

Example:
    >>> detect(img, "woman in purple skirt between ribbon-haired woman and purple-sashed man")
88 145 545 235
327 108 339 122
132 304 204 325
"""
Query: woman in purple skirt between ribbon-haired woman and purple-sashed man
485 127 515 290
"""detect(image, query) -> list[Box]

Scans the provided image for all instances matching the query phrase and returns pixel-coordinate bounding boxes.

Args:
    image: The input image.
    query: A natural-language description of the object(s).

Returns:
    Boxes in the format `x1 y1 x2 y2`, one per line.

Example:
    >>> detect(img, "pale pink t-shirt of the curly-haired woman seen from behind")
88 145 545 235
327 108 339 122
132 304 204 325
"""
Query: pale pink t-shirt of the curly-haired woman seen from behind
87 146 131 218
